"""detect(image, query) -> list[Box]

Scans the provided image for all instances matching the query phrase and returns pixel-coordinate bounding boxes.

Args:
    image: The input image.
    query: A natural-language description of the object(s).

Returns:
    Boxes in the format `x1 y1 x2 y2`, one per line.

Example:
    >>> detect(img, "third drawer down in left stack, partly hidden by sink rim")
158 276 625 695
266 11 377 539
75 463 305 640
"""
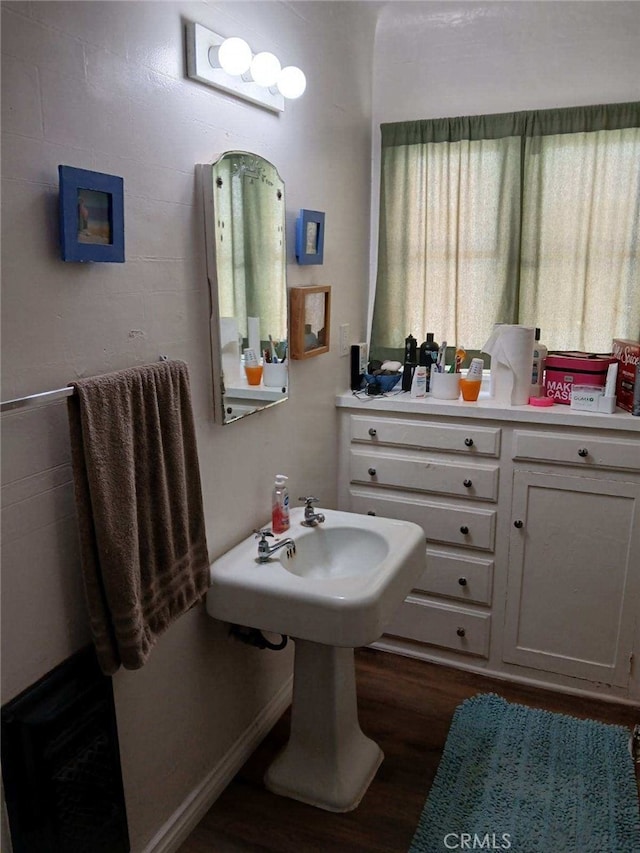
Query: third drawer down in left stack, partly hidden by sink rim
349 489 496 551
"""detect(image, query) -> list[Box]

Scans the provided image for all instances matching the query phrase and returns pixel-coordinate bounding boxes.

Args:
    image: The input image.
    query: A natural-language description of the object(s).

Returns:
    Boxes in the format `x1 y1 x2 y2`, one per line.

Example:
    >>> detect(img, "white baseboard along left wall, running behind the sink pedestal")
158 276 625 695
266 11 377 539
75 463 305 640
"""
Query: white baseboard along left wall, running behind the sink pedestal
143 676 293 853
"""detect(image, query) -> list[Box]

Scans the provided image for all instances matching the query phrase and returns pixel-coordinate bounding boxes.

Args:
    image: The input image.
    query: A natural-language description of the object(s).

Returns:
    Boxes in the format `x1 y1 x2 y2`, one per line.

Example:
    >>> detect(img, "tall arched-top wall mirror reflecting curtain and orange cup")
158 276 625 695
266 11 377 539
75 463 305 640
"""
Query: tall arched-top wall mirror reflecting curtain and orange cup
198 151 289 424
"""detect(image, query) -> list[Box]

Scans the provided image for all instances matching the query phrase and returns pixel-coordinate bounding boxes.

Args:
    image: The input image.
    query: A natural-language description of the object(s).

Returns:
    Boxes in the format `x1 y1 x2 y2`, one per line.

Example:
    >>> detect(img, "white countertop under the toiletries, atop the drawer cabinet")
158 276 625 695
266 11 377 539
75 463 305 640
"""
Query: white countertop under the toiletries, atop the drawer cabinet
336 391 640 436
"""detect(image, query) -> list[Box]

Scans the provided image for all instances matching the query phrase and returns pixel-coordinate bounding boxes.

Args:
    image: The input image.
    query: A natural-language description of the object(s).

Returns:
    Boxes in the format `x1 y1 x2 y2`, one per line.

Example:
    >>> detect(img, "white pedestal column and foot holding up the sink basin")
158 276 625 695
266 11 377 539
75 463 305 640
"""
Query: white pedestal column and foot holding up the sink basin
264 640 384 812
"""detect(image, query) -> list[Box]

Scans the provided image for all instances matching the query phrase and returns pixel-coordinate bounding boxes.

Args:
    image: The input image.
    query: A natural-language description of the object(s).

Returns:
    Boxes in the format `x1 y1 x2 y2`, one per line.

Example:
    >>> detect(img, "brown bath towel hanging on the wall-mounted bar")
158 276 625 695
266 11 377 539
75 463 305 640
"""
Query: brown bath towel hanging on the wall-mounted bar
68 361 209 675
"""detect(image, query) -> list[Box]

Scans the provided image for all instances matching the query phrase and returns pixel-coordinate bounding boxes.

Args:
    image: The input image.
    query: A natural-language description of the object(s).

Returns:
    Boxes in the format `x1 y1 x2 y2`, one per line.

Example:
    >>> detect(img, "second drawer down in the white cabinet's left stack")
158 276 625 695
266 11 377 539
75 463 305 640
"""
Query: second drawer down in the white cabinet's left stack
349 450 500 501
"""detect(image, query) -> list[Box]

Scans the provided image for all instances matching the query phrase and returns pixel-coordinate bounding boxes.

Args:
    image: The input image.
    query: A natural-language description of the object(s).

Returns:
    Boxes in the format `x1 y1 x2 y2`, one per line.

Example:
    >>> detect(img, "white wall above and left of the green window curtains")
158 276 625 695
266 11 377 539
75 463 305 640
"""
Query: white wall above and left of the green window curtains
371 0 640 332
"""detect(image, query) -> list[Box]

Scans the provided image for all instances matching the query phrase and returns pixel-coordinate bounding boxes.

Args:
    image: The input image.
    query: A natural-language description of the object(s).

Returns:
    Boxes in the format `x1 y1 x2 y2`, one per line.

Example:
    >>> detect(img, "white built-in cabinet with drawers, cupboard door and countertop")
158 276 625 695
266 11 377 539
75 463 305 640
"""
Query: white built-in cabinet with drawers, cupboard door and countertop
338 395 640 701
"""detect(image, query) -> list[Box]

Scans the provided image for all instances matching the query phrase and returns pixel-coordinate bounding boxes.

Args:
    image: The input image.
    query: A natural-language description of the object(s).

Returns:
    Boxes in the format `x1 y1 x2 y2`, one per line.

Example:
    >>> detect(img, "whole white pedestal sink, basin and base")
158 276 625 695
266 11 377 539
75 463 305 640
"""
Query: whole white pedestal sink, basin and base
207 508 426 812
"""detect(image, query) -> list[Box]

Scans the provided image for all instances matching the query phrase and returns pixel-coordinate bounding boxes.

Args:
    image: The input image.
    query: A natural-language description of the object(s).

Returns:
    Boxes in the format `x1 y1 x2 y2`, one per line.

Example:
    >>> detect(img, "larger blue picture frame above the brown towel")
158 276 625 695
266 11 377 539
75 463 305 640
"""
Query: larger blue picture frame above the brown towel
58 166 124 264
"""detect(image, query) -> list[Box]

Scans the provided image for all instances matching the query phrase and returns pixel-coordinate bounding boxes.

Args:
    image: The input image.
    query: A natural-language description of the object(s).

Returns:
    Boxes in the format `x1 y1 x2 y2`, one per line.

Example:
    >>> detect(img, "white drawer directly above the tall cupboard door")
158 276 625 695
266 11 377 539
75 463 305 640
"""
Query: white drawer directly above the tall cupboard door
513 430 640 471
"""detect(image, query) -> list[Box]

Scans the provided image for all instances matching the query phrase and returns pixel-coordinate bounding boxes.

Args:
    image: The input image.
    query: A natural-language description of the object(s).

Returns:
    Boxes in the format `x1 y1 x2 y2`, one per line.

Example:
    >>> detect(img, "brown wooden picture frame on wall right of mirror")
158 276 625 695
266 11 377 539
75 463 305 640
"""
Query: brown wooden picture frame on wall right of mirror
289 285 331 359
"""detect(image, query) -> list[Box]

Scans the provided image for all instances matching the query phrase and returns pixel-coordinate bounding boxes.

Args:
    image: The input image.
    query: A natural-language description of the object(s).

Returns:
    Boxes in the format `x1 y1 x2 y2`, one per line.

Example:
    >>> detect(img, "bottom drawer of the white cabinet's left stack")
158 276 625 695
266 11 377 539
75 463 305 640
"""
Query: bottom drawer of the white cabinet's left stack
385 595 491 658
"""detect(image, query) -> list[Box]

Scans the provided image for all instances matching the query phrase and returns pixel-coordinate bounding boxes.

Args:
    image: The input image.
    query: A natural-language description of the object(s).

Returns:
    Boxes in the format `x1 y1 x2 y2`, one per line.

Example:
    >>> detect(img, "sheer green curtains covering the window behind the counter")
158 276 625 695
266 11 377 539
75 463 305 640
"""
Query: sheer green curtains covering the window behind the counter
371 102 640 358
